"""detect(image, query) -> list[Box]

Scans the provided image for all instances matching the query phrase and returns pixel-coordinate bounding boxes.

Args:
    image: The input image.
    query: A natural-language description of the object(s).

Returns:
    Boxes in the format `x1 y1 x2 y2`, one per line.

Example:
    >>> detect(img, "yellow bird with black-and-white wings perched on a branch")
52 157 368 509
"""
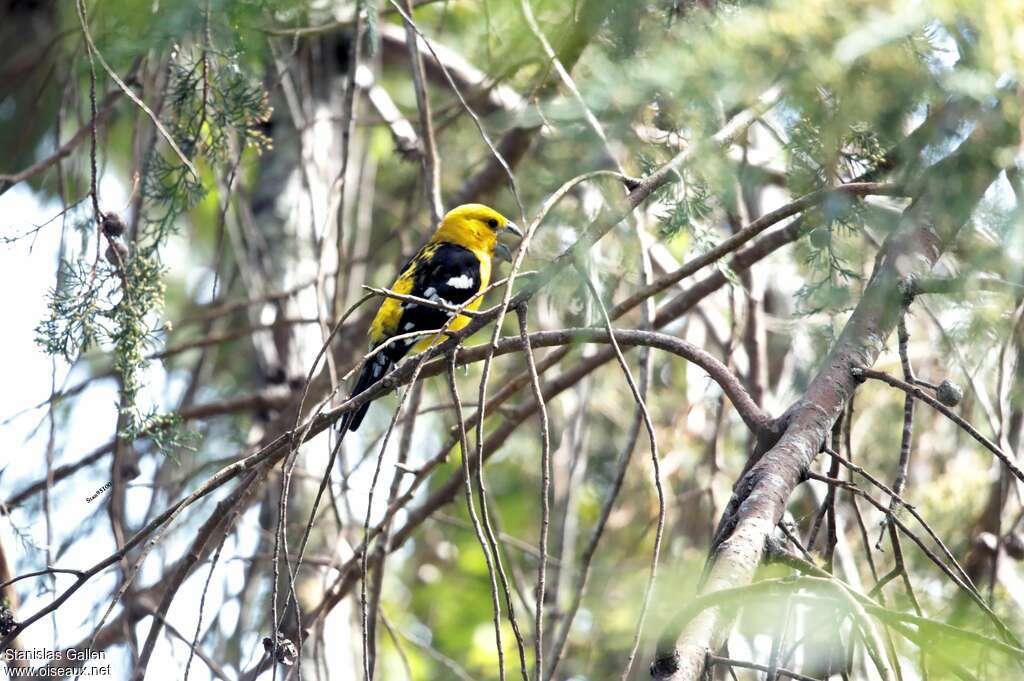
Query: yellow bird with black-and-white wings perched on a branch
340 204 523 432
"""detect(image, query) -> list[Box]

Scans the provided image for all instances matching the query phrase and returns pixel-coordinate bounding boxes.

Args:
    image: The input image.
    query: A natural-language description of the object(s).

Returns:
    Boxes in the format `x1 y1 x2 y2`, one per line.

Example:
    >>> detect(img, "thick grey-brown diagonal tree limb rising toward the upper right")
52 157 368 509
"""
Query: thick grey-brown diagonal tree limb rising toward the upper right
652 104 1016 681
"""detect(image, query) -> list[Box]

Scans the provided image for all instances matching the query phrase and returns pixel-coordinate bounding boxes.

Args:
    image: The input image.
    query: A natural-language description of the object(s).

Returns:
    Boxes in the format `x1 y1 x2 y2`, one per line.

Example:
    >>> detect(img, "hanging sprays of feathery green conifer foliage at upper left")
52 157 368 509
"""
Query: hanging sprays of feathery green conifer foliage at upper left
37 10 271 451
